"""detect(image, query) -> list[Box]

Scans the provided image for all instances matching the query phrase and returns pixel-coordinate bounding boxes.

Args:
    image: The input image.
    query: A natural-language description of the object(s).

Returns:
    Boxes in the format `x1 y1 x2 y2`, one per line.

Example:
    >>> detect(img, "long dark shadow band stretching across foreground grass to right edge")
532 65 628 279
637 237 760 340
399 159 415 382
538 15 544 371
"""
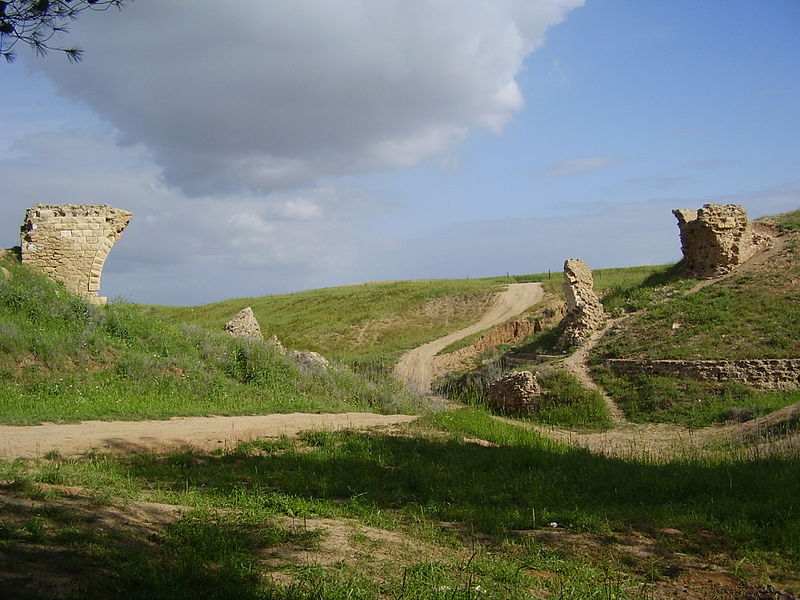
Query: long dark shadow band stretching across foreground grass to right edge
111 410 800 562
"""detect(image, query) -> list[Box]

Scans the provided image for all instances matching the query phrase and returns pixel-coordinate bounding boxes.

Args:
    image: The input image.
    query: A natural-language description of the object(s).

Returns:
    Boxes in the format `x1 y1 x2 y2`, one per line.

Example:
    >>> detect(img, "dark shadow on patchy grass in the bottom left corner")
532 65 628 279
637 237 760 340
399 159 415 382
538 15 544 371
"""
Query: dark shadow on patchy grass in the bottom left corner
0 486 318 600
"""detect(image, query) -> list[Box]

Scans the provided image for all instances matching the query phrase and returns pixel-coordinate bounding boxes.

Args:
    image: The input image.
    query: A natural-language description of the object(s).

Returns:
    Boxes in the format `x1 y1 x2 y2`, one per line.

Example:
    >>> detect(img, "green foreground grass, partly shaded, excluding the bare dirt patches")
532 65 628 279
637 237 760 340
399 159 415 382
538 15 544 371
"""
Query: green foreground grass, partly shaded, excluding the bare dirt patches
0 409 800 599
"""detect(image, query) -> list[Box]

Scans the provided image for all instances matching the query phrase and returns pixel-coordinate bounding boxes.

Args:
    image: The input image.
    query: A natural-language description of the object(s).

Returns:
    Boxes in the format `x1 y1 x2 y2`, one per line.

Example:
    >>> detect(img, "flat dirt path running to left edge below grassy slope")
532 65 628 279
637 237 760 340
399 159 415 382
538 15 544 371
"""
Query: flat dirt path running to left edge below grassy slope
0 413 417 458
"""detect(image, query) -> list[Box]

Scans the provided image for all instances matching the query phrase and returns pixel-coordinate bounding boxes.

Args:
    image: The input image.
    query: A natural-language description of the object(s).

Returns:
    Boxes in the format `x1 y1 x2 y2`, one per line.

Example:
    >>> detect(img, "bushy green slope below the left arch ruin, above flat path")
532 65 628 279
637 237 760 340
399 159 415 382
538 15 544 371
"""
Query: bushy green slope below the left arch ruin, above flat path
0 255 414 424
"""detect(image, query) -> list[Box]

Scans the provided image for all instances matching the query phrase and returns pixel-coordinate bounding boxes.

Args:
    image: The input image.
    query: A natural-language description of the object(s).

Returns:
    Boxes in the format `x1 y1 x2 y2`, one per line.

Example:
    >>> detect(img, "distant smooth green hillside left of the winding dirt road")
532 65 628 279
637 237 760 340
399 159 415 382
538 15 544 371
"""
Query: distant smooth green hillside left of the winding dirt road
147 278 504 368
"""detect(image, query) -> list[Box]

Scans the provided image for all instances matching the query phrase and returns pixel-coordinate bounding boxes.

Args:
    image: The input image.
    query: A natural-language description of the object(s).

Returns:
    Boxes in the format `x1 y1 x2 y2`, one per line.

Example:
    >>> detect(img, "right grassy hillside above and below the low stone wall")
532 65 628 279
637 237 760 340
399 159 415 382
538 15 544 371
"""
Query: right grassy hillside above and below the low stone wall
592 211 800 426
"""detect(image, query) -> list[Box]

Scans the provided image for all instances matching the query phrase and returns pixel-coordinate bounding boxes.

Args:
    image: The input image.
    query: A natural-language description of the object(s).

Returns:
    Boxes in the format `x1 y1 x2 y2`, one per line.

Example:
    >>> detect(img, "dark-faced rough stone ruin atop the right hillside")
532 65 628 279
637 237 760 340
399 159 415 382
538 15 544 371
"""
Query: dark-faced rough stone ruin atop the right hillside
672 204 763 277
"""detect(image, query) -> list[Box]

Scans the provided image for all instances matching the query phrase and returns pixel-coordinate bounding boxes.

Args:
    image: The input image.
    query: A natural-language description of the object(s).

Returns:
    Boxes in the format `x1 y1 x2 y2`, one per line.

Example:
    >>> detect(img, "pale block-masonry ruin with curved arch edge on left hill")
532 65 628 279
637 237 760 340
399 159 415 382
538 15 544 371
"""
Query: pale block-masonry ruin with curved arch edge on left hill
21 204 133 304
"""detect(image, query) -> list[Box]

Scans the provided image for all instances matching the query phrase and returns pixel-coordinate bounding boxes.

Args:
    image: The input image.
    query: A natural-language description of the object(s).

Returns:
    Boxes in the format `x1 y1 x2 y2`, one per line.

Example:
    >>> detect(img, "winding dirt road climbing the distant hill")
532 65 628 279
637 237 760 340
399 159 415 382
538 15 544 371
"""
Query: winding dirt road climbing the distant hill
395 283 544 394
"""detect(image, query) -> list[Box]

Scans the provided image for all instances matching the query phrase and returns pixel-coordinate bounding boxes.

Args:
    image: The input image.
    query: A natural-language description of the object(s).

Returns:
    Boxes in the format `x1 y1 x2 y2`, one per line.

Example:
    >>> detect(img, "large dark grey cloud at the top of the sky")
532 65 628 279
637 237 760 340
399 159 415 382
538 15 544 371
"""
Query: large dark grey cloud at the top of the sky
34 0 583 196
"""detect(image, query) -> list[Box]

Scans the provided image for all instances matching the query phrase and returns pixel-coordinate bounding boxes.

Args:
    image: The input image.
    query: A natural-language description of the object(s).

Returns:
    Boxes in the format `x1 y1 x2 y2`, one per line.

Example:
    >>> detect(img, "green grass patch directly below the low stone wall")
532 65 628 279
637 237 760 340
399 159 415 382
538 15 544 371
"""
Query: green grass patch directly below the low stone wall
594 367 800 427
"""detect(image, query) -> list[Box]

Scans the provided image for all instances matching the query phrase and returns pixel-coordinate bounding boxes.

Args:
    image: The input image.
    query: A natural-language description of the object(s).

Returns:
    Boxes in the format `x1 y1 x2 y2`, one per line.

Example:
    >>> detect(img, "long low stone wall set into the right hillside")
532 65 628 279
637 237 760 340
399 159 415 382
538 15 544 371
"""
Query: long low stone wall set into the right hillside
606 358 800 390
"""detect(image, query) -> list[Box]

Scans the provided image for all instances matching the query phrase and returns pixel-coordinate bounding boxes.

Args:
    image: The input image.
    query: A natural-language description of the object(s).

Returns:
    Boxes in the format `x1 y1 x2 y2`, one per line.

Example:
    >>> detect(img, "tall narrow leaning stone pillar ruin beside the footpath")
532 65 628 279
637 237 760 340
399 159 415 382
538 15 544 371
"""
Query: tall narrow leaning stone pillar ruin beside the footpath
559 258 606 348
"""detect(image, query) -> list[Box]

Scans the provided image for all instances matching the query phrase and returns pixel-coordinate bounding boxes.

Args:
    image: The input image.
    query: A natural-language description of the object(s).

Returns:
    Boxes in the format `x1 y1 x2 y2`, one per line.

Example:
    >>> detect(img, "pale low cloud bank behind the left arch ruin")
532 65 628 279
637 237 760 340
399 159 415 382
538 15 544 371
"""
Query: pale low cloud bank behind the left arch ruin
0 131 384 303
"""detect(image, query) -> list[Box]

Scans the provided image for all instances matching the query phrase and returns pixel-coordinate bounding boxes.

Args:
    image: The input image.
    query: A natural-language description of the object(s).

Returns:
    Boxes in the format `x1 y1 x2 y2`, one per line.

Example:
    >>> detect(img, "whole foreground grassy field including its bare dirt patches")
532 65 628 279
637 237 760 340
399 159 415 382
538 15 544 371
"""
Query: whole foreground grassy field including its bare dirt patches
0 409 800 600
